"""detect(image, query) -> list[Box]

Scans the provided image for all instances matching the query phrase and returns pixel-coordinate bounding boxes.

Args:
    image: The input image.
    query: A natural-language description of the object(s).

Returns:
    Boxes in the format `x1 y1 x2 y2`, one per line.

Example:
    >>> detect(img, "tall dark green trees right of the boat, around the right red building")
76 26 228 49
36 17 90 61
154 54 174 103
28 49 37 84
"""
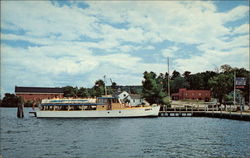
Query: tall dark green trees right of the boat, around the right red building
142 65 249 104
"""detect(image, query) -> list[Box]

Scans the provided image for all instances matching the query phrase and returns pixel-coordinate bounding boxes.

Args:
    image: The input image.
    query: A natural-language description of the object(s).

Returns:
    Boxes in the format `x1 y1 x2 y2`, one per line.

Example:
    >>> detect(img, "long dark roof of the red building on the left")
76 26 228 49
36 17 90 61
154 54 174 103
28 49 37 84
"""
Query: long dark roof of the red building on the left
15 86 63 93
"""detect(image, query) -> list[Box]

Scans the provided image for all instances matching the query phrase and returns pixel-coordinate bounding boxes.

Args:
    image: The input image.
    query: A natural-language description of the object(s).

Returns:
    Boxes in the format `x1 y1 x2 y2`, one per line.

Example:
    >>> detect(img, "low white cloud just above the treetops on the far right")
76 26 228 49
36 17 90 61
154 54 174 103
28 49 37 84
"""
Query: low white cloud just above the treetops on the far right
173 48 249 73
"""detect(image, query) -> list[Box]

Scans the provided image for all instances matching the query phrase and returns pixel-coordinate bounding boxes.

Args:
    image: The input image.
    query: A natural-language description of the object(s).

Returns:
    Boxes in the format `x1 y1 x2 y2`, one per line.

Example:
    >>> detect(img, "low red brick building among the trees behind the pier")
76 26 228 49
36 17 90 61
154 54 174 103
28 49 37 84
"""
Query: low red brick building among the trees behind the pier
171 88 211 101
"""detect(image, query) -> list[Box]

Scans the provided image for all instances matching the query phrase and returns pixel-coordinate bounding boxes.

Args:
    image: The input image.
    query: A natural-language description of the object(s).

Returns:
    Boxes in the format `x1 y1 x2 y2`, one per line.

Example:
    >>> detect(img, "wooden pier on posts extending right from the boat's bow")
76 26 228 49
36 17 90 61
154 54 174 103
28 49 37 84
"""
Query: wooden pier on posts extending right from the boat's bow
159 106 250 121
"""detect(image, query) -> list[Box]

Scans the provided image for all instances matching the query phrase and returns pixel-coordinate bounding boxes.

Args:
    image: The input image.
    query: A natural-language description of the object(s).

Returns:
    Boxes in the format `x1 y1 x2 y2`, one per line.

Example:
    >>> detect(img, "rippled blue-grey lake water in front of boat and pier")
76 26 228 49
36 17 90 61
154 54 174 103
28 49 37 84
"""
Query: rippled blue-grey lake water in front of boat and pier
0 108 250 158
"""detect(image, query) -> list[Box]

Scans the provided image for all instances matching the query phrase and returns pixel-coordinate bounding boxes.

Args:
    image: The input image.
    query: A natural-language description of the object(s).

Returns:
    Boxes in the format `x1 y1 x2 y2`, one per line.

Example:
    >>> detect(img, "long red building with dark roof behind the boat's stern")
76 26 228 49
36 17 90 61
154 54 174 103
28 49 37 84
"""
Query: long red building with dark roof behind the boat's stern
15 86 63 101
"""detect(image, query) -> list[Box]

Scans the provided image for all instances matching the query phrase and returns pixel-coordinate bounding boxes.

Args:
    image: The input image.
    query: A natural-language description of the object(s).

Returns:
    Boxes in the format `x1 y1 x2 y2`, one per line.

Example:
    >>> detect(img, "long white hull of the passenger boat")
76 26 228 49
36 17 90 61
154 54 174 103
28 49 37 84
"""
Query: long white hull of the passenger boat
36 106 160 118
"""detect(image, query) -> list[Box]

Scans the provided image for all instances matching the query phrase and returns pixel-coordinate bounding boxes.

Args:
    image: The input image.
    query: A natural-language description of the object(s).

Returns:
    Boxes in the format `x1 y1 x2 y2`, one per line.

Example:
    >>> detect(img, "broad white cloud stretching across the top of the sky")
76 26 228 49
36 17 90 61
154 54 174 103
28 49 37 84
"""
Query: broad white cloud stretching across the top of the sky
2 2 249 47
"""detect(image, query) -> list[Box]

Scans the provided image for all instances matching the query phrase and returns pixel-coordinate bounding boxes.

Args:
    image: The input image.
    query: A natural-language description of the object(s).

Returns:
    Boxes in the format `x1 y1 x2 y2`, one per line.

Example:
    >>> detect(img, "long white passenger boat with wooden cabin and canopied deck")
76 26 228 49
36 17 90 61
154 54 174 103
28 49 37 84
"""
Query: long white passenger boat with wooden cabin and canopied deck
36 97 160 118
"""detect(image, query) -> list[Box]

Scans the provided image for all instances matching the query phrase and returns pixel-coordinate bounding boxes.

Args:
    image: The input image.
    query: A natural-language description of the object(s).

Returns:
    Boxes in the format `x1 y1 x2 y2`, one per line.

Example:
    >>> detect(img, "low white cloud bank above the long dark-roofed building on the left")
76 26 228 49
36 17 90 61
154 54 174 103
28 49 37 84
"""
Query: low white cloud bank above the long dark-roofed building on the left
1 45 168 90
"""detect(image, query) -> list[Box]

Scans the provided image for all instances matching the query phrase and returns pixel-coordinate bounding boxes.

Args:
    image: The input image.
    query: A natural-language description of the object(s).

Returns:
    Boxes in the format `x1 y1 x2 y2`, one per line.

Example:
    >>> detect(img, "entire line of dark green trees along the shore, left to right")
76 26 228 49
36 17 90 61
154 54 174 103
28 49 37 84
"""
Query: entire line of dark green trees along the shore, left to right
0 65 249 106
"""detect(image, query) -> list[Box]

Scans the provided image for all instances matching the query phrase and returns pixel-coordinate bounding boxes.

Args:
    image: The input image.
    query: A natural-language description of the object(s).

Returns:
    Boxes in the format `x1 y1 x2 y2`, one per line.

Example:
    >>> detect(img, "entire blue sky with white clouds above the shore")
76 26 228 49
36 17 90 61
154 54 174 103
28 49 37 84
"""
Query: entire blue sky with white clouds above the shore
1 0 249 95
